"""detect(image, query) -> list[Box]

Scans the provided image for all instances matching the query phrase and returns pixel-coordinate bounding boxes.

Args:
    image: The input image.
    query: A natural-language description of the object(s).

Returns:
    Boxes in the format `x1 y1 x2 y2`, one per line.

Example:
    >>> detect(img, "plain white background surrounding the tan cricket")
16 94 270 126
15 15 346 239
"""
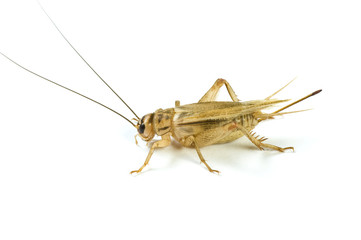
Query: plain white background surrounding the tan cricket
0 0 361 239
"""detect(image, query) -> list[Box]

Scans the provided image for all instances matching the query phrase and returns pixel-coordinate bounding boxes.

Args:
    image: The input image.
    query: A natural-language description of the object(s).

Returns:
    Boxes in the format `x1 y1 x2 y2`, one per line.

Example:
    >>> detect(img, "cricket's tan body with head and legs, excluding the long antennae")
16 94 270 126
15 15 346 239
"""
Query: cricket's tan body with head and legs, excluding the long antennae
131 78 321 173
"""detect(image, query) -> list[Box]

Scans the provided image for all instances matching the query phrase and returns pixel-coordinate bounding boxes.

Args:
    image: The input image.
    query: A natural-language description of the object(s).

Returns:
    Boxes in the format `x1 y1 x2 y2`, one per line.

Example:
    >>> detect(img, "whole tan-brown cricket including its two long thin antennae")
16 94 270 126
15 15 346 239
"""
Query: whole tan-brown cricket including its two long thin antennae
0 6 322 174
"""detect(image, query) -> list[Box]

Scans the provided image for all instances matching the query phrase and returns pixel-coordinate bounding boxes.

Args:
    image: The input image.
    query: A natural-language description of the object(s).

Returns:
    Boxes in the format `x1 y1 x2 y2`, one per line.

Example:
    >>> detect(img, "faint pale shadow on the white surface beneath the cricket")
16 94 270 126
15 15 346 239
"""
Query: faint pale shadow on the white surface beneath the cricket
134 136 302 175
